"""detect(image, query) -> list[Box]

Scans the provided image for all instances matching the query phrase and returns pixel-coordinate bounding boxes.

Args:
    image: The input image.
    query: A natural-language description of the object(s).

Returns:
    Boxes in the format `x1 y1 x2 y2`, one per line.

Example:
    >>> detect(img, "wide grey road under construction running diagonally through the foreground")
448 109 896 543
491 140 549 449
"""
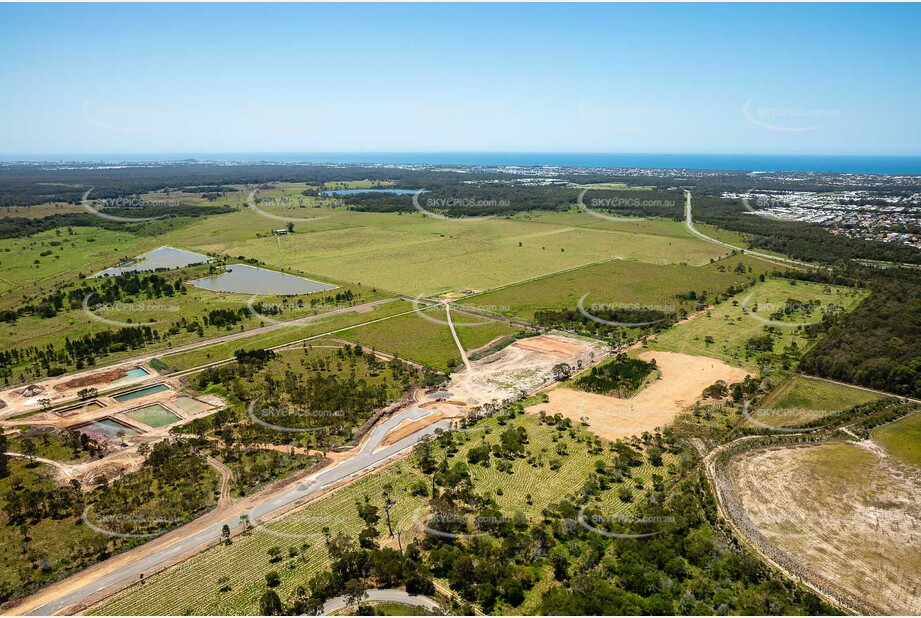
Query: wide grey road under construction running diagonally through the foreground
29 407 450 616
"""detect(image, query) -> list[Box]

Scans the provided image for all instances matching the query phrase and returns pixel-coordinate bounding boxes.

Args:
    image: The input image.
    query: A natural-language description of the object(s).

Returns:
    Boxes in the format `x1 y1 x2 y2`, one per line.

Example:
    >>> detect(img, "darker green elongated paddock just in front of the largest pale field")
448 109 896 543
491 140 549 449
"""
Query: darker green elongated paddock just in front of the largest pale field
463 256 768 320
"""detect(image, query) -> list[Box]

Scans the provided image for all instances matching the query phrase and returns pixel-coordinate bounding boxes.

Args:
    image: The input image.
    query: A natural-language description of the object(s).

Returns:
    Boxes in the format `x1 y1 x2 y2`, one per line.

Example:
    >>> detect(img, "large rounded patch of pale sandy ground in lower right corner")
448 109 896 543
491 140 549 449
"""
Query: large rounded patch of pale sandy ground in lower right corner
730 443 921 615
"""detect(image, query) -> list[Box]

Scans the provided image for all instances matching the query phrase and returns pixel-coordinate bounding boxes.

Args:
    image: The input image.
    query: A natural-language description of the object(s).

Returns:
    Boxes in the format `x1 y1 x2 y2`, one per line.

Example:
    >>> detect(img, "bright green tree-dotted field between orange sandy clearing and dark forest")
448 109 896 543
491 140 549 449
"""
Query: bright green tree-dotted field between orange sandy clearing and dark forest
649 278 866 367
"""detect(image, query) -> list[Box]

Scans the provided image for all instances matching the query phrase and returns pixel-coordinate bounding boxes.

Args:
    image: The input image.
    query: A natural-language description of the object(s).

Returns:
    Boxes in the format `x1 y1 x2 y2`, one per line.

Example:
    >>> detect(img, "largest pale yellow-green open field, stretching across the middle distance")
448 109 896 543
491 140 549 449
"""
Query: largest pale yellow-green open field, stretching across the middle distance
160 208 728 295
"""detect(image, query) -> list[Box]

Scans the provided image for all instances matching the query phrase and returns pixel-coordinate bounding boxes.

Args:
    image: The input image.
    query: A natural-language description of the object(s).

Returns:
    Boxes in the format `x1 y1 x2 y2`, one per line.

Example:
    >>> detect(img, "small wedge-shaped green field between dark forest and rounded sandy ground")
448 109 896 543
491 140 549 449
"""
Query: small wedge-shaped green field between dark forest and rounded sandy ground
752 375 880 427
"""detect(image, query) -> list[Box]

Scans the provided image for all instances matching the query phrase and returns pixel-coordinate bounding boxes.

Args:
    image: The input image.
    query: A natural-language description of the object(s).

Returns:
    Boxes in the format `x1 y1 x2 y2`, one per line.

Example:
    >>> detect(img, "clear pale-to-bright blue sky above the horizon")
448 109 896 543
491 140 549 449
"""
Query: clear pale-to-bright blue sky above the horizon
0 4 921 155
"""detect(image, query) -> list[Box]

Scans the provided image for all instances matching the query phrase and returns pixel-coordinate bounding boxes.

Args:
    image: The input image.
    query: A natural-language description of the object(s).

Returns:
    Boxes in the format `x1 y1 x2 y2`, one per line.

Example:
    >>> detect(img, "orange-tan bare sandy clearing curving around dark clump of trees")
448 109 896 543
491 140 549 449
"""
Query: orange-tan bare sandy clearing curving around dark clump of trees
528 352 748 440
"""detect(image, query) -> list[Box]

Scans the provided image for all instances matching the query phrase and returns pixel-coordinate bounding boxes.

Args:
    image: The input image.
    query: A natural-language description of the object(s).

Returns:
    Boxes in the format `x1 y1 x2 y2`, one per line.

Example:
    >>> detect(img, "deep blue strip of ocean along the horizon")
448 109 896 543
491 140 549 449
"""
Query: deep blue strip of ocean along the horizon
7 152 921 174
